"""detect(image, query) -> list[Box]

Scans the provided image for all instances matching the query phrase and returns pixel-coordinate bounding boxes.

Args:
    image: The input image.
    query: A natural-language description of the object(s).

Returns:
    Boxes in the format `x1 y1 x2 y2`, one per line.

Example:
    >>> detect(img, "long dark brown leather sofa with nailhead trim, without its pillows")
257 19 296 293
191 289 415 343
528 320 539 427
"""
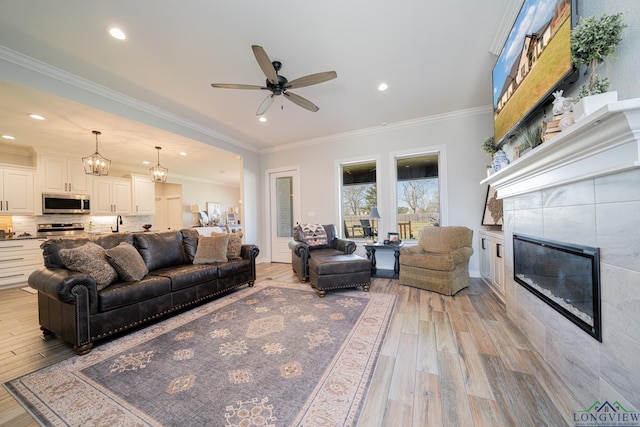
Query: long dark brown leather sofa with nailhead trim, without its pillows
29 229 259 354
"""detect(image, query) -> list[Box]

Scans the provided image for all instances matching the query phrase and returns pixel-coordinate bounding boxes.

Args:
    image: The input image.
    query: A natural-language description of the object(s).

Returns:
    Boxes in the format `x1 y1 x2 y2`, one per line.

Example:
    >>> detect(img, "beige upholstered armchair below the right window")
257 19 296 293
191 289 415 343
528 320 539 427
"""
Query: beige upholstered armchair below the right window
400 227 473 295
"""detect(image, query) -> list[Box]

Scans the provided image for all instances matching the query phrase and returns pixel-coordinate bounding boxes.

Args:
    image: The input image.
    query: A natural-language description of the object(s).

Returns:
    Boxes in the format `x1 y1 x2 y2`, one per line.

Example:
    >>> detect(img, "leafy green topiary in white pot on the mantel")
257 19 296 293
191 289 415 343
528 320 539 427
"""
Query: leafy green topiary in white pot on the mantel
571 13 627 118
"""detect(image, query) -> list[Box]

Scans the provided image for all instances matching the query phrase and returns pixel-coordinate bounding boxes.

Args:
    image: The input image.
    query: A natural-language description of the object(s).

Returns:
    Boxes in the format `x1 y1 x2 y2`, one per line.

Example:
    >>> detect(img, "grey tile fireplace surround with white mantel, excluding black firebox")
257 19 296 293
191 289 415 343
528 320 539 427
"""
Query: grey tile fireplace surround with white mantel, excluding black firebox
482 98 640 410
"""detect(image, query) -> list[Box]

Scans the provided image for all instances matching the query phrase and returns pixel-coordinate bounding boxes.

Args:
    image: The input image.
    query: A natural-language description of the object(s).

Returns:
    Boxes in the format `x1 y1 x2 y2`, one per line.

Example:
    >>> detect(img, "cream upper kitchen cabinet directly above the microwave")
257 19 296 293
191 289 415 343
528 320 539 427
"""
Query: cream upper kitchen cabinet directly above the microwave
38 156 91 194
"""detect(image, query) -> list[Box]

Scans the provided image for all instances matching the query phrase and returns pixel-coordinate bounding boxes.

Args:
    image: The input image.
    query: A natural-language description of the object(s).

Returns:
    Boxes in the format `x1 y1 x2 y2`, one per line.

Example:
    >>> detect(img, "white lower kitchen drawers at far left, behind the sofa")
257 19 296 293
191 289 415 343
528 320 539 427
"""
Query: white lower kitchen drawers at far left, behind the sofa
0 239 45 289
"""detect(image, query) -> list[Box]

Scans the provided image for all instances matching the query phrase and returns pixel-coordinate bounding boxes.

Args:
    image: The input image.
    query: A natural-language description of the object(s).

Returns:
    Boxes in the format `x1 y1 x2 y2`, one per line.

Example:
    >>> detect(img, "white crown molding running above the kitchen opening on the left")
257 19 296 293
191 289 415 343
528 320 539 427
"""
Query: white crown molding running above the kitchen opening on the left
0 45 259 153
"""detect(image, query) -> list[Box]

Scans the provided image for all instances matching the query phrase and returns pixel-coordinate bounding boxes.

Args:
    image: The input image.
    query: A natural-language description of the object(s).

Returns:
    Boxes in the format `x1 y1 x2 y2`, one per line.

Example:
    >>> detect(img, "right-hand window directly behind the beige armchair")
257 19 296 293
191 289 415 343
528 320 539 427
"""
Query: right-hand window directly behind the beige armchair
396 153 440 239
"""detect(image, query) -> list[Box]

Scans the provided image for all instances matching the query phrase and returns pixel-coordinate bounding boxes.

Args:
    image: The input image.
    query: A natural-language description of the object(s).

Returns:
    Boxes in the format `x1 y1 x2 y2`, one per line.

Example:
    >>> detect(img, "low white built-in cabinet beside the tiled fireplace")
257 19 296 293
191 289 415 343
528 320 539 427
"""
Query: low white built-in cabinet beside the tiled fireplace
479 230 505 301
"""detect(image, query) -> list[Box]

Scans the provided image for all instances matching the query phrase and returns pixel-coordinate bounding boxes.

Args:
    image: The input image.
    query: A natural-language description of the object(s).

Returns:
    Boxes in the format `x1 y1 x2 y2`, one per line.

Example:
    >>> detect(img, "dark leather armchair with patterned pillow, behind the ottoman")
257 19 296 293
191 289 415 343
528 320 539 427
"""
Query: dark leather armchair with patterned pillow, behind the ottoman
289 224 357 282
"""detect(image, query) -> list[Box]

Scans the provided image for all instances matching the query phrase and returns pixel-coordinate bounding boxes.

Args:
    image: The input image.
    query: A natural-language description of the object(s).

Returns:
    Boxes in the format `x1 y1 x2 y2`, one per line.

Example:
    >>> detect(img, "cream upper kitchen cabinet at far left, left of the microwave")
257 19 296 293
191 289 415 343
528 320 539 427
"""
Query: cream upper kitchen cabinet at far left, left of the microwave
0 167 36 215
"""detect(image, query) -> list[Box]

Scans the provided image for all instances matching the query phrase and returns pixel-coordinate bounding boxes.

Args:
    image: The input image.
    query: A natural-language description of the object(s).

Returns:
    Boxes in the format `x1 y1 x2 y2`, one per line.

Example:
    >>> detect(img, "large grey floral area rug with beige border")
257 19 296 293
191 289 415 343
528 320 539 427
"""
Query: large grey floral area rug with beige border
5 280 395 427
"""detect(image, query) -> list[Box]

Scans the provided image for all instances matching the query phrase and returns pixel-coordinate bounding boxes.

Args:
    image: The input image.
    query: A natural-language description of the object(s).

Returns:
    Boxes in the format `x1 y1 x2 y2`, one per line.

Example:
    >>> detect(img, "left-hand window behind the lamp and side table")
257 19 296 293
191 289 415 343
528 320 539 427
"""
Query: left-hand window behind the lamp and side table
338 160 378 238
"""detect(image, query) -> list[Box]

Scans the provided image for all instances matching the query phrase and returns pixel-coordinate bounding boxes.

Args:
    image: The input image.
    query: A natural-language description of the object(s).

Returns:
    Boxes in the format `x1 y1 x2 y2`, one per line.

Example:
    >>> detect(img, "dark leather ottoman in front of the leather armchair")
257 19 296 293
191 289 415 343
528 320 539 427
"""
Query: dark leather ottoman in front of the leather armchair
309 254 371 297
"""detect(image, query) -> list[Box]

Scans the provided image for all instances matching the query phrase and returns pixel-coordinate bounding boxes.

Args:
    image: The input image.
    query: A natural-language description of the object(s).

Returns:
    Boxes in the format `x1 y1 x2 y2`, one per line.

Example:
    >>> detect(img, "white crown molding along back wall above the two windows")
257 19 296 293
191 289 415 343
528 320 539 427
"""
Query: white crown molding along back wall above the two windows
260 105 493 154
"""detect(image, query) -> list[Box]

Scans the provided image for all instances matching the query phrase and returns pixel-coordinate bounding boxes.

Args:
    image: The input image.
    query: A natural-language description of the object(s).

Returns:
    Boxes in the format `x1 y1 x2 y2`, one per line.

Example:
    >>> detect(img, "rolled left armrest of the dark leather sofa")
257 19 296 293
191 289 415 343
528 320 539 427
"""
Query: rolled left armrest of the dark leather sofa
29 268 98 304
